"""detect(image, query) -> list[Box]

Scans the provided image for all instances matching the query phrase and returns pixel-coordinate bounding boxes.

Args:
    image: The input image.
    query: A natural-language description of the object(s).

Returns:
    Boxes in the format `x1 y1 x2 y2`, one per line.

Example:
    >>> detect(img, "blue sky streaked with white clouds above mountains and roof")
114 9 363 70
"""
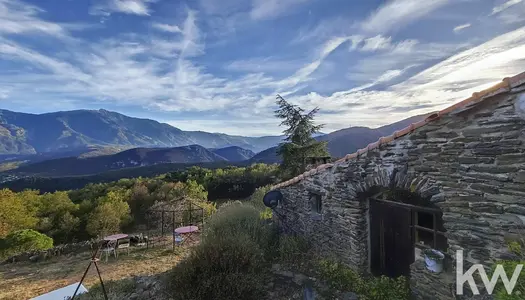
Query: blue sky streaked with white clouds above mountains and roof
0 0 525 135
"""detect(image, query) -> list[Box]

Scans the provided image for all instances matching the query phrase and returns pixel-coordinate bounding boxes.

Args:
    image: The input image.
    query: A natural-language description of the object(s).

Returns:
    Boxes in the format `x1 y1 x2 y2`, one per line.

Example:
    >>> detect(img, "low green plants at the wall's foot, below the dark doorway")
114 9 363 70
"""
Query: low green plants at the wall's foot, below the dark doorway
318 260 410 300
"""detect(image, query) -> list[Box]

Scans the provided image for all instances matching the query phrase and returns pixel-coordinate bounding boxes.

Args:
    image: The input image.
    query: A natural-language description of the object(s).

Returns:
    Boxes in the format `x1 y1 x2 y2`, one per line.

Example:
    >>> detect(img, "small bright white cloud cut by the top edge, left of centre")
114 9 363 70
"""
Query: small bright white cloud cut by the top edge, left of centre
90 0 153 16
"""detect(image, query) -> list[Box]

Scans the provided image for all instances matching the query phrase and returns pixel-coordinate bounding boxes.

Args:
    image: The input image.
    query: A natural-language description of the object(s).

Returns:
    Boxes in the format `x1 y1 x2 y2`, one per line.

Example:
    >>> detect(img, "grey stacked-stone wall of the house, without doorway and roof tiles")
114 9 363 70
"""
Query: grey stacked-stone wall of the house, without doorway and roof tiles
274 87 525 299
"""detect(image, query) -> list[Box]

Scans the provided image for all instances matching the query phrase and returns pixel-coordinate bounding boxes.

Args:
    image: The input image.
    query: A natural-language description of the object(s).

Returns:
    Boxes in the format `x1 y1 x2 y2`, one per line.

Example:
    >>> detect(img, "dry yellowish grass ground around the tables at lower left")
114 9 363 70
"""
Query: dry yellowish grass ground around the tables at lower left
0 239 194 299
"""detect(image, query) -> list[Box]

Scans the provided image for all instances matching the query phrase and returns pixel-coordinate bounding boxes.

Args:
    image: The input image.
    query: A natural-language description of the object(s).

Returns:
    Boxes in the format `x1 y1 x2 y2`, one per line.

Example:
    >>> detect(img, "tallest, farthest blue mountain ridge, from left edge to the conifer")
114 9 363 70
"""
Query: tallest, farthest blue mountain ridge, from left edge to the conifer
0 109 281 155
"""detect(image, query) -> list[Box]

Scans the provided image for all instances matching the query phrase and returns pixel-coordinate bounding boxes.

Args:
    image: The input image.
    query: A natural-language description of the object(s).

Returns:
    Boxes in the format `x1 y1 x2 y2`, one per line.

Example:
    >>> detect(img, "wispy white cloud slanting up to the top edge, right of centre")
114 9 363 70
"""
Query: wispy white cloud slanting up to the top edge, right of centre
361 0 451 33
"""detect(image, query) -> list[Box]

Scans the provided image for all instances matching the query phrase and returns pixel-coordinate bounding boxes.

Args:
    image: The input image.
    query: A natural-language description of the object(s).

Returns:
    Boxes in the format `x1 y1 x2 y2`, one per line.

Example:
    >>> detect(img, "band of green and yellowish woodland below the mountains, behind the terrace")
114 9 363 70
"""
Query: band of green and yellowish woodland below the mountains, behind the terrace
0 164 277 258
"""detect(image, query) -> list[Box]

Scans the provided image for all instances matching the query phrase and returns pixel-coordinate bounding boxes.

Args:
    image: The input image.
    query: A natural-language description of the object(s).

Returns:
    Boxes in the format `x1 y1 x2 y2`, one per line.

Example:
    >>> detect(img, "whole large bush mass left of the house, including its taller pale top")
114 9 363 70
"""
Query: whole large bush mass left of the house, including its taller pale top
168 201 277 300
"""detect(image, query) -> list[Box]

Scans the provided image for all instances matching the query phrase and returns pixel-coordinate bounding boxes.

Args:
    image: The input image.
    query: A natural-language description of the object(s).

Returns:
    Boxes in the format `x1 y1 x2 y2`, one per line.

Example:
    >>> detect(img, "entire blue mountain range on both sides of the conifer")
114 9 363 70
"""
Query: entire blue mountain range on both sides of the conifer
0 110 424 177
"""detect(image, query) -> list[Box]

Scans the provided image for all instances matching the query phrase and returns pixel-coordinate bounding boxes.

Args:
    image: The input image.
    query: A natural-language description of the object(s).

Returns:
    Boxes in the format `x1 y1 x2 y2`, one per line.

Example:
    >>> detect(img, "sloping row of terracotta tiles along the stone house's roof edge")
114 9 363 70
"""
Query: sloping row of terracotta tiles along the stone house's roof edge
272 72 525 189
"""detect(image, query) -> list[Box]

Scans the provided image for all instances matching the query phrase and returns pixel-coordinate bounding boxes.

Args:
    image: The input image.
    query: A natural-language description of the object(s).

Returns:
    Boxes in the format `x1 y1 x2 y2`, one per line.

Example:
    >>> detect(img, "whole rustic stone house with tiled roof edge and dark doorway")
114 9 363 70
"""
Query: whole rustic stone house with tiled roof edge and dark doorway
272 73 525 299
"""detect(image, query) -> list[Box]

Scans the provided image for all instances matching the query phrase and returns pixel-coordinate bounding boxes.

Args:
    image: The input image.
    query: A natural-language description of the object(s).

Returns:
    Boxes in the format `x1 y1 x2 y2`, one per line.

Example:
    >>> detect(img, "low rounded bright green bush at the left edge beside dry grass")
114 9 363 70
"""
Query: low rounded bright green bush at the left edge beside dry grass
0 229 53 258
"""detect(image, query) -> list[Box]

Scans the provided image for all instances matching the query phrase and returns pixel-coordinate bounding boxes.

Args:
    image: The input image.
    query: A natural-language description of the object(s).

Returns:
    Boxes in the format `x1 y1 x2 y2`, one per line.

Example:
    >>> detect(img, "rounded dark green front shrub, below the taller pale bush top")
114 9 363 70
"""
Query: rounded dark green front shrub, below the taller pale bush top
168 233 265 300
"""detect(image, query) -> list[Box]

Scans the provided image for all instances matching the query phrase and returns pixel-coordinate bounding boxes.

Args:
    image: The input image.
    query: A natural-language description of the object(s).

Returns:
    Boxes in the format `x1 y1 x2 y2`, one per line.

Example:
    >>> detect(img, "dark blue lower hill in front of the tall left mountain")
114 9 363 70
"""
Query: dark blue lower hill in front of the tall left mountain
8 145 227 177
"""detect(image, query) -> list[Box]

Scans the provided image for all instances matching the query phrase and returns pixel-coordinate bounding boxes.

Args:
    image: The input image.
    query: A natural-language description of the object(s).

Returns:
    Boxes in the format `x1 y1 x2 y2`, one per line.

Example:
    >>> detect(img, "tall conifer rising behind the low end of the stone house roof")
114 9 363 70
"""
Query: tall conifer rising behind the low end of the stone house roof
275 95 329 178
